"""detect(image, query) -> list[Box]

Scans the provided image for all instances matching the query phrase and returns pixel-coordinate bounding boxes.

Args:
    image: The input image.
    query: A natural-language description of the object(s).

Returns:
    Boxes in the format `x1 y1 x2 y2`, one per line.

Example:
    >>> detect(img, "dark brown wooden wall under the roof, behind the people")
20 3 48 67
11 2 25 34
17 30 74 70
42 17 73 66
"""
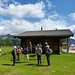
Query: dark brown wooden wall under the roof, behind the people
21 37 68 53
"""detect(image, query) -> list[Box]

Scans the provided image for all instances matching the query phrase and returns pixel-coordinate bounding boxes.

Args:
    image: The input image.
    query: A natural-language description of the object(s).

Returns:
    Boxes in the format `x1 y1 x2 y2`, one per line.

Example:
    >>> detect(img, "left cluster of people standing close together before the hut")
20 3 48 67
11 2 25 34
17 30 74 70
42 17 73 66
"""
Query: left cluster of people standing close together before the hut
12 42 32 66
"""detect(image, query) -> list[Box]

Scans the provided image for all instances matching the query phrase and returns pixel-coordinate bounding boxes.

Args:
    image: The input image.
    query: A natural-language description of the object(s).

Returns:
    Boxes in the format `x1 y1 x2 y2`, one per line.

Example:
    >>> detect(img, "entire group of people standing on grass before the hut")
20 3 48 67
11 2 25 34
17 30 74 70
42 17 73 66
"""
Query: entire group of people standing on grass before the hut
12 42 53 66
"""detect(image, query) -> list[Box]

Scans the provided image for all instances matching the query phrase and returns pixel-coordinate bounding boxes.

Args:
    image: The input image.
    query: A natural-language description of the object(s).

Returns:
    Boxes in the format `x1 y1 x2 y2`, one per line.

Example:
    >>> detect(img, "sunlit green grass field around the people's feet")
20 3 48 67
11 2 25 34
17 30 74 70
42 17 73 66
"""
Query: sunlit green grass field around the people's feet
0 47 75 75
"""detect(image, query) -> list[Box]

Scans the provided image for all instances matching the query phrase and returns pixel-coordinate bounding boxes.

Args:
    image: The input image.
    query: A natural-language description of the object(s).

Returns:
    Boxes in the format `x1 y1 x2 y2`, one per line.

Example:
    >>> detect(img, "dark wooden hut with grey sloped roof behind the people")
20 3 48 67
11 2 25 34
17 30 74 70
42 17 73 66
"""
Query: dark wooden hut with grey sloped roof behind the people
14 29 74 53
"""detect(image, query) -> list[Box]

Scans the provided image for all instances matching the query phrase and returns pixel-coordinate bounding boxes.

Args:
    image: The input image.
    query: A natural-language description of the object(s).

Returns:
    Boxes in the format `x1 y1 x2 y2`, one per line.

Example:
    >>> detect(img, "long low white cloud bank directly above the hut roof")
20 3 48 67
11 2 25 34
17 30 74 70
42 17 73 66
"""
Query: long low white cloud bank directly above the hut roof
0 14 67 34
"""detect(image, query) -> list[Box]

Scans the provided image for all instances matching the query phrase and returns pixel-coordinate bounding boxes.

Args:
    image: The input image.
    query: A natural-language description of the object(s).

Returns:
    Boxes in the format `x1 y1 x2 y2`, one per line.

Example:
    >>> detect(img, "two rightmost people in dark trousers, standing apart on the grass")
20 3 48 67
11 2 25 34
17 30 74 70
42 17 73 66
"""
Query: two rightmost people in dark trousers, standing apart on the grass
36 42 53 66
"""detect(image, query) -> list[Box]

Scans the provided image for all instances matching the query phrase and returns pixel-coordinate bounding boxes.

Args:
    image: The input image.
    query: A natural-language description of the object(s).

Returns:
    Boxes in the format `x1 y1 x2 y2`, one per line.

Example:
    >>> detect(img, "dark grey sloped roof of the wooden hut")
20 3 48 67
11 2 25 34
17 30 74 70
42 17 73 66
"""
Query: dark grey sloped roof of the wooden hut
14 29 74 37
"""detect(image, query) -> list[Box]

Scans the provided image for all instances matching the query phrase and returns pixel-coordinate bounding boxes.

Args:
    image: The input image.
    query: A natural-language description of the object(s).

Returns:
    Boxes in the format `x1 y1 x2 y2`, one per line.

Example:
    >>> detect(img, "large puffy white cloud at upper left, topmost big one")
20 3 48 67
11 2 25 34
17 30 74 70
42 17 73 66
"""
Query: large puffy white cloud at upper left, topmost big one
0 2 45 18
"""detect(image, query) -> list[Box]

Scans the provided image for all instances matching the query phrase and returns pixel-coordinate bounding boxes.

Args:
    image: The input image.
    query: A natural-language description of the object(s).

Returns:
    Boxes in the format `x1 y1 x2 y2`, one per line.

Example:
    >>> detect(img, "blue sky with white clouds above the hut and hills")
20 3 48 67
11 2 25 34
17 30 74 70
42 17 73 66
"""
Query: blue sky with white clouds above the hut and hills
0 0 75 38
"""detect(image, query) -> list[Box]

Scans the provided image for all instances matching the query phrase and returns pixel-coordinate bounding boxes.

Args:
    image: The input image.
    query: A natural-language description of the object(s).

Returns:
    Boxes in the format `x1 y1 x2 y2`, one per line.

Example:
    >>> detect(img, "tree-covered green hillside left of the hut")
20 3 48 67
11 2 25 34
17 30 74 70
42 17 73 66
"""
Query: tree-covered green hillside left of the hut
0 34 20 46
